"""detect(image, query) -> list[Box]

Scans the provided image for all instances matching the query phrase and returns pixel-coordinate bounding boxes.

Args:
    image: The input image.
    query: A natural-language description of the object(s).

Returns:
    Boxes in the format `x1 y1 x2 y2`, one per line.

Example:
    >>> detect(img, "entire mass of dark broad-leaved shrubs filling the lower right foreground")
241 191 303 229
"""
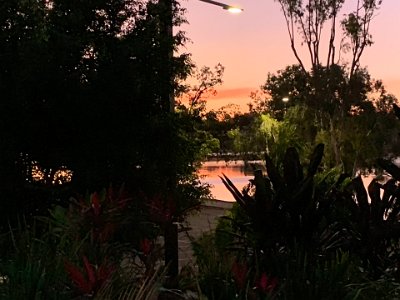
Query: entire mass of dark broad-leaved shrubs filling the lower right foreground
195 144 400 299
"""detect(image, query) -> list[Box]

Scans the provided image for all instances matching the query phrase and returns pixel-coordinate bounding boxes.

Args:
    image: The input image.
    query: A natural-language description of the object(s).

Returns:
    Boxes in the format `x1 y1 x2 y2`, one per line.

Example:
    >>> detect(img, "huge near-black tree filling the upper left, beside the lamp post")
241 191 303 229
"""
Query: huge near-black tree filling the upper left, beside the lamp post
0 0 206 220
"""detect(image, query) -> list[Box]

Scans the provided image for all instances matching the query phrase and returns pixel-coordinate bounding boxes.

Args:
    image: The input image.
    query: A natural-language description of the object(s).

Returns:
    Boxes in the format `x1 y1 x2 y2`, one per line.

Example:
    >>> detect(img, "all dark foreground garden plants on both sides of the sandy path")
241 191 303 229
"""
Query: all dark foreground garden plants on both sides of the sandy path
0 138 400 299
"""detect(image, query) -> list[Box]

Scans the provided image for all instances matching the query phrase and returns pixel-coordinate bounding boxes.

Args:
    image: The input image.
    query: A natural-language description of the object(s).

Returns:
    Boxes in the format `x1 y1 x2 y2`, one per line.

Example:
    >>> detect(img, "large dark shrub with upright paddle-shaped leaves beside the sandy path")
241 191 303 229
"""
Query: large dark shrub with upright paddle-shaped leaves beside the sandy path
216 145 351 299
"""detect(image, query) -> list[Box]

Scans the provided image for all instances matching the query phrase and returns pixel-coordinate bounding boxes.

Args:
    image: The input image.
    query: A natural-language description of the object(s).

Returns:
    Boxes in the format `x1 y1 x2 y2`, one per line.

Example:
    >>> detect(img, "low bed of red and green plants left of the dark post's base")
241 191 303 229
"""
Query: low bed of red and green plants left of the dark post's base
0 188 181 299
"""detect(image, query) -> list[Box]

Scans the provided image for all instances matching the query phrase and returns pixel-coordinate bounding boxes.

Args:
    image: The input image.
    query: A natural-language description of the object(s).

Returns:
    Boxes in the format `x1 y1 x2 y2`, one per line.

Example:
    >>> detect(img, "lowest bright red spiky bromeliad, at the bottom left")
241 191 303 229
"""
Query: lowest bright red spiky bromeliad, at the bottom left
64 256 113 295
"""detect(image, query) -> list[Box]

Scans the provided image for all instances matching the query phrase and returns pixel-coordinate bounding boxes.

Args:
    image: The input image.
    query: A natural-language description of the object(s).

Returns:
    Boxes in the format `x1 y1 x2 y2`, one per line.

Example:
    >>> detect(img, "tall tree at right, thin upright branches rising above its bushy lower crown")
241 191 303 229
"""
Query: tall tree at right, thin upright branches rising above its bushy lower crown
241 0 398 174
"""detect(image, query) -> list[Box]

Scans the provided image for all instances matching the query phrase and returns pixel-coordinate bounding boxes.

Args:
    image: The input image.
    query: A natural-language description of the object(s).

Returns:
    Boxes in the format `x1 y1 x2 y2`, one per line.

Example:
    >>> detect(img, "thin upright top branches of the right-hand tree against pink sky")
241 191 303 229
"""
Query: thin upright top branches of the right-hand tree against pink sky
275 0 382 77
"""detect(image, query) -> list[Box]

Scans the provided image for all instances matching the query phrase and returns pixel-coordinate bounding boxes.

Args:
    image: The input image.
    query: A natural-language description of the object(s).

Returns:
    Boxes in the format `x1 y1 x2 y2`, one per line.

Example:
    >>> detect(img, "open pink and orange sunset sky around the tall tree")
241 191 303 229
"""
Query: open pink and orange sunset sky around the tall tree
181 0 400 108
